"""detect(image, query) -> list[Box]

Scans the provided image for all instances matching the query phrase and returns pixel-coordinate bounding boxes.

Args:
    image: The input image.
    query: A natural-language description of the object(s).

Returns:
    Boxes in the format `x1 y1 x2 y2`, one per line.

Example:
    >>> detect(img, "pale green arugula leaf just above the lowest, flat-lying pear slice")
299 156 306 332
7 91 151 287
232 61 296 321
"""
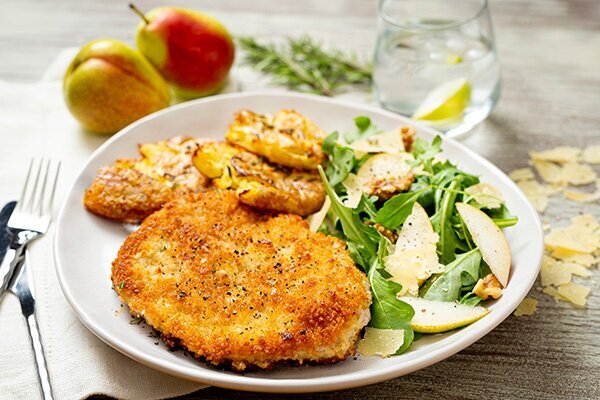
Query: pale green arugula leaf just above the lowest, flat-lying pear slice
419 249 481 301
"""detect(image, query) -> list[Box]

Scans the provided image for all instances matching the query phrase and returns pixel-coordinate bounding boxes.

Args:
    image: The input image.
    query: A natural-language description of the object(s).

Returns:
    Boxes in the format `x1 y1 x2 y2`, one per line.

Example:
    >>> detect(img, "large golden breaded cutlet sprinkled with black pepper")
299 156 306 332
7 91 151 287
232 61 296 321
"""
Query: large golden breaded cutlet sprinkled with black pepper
112 190 371 371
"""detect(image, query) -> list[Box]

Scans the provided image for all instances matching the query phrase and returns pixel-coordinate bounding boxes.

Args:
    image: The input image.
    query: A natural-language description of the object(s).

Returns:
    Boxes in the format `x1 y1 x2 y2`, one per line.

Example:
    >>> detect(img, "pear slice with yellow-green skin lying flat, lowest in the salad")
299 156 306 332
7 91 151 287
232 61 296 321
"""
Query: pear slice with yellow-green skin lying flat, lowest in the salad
399 296 490 333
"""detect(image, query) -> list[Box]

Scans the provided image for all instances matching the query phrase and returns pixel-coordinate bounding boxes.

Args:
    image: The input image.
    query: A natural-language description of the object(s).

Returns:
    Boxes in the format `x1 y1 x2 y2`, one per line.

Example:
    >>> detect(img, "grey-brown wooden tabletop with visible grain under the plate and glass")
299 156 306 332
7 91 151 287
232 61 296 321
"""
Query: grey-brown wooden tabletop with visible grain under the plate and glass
0 0 600 400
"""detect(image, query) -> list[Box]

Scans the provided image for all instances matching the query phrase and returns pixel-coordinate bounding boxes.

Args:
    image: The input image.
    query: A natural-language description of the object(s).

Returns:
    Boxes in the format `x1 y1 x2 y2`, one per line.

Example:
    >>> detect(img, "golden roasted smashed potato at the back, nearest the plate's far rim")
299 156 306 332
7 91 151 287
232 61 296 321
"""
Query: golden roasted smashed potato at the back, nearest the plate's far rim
225 110 325 169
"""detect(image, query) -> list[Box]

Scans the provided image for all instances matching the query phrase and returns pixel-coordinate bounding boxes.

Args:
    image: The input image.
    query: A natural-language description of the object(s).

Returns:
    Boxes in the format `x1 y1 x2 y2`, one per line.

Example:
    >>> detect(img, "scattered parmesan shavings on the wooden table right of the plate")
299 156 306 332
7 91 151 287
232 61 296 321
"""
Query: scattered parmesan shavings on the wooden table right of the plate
509 145 600 308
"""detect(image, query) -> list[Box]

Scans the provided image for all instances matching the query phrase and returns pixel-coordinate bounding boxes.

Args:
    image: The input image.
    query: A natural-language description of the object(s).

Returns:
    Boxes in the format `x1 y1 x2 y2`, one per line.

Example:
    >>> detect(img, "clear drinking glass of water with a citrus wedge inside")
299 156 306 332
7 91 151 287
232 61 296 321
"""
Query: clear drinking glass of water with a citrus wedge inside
373 0 500 137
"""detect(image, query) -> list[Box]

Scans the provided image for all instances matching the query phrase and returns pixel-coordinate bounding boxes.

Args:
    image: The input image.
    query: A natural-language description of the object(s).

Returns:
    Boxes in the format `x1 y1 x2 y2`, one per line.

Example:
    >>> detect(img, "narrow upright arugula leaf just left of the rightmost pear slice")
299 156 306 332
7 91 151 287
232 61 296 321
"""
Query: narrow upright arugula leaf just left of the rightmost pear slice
431 175 463 265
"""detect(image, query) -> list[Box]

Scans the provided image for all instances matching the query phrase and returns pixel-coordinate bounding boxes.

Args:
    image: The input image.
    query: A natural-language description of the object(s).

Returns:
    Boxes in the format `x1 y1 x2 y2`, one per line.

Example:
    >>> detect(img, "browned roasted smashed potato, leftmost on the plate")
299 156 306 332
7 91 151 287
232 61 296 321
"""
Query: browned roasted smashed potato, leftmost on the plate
83 136 209 223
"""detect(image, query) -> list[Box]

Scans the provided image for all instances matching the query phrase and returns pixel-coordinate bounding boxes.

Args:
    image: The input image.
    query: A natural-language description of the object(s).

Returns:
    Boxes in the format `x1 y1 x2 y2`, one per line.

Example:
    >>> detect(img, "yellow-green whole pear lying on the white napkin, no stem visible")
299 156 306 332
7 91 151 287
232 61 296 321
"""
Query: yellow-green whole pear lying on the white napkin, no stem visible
63 39 170 134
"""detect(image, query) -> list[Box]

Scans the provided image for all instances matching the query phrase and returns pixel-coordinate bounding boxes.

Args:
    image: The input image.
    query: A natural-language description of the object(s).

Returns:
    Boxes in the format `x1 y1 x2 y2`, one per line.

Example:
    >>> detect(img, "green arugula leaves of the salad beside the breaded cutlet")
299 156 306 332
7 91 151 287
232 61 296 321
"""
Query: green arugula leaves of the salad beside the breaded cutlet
319 116 517 354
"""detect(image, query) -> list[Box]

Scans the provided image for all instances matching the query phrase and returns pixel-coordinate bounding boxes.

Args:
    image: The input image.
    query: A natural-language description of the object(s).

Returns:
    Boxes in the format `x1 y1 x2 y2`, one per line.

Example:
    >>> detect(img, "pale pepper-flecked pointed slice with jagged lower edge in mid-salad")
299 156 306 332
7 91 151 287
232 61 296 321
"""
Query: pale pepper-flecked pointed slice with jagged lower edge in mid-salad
383 203 443 296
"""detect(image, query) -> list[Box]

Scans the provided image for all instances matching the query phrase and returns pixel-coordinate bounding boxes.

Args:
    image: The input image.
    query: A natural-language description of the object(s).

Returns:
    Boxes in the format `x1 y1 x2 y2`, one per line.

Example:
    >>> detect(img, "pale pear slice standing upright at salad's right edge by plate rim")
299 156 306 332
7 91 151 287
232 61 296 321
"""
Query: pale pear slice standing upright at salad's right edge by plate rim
455 203 510 287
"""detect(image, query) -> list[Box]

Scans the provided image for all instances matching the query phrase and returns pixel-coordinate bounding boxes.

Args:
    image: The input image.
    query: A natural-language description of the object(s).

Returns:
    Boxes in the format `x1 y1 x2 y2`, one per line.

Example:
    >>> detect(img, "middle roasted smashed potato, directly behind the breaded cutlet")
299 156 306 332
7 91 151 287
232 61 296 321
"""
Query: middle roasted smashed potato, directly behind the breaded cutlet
193 142 325 216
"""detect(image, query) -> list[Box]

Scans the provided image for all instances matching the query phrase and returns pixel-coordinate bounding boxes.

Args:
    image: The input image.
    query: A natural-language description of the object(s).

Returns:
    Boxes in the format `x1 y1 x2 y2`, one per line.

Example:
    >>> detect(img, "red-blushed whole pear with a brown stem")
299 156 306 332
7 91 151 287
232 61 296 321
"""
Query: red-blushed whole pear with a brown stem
130 5 235 99
